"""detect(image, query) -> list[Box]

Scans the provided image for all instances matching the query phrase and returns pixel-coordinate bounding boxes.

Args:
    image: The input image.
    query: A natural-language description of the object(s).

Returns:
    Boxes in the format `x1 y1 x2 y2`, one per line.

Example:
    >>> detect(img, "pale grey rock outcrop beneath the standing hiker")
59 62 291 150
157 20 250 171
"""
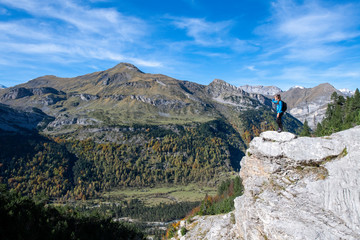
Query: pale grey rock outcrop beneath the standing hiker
182 126 360 240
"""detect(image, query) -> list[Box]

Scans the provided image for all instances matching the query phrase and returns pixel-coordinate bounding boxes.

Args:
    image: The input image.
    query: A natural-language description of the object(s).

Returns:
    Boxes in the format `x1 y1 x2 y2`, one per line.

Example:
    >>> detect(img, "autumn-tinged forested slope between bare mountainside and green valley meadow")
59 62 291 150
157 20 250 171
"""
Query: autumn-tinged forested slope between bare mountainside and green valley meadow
0 121 243 202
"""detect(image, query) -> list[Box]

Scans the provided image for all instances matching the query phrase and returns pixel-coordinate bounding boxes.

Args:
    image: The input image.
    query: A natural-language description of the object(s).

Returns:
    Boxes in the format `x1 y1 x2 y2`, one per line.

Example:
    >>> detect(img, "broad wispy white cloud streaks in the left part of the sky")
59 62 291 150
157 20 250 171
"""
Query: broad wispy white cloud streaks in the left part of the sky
0 0 162 67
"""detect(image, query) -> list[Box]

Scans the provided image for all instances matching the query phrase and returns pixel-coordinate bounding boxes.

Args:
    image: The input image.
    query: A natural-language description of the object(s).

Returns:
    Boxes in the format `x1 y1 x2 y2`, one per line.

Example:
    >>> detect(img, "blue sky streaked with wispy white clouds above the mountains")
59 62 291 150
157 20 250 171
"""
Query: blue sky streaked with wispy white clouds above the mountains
0 0 360 90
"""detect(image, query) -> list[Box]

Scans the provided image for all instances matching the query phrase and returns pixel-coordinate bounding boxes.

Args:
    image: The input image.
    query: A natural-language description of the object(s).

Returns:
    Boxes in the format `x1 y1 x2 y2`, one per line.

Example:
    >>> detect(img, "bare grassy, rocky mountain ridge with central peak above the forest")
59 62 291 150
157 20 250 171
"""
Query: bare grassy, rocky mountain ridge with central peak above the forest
0 63 301 140
